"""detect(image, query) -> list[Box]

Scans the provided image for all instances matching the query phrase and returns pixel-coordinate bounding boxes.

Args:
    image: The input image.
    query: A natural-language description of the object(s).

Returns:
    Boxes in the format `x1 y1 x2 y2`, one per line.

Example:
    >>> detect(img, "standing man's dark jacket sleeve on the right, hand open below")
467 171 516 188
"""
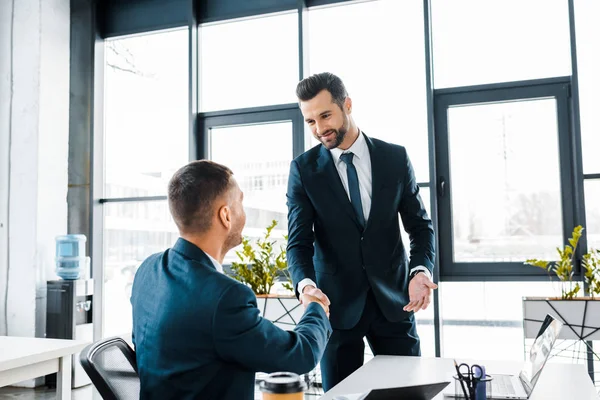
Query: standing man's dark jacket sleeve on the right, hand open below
398 148 435 275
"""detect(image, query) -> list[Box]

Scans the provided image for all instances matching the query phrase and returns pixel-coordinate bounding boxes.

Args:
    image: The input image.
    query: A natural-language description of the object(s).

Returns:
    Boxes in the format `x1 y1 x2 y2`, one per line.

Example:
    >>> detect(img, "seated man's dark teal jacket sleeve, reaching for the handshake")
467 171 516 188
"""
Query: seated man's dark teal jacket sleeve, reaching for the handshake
213 285 331 374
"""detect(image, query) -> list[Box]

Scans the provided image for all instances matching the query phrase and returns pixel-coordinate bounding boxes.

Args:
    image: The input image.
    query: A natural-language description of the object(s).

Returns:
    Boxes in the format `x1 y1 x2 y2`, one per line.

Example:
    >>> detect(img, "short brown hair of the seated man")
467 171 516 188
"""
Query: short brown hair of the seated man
169 160 233 233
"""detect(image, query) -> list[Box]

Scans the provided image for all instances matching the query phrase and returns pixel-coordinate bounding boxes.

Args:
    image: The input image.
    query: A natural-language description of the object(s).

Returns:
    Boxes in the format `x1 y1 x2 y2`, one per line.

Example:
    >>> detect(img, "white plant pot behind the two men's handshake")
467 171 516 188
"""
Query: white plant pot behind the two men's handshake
256 294 304 331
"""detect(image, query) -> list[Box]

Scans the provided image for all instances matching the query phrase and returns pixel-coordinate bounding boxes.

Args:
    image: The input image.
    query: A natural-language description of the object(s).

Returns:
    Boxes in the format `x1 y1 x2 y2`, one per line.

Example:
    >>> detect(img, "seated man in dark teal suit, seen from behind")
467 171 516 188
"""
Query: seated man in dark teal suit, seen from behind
131 160 331 400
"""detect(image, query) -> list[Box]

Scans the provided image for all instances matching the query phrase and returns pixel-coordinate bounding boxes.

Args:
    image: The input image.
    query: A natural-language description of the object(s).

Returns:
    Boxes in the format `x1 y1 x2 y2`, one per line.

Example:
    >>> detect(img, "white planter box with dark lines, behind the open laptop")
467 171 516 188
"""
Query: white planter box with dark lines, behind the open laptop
523 297 600 340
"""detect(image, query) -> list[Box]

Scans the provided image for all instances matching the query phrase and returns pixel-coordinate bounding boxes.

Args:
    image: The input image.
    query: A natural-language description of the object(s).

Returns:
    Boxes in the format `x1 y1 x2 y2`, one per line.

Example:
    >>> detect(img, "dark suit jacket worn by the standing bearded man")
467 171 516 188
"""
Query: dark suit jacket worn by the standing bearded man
287 133 434 329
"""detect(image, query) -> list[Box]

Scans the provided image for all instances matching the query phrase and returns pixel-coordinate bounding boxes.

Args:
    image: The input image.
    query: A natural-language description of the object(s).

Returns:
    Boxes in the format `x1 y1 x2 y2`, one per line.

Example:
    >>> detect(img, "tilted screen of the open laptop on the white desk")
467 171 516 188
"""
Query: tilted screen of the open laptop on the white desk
519 314 563 395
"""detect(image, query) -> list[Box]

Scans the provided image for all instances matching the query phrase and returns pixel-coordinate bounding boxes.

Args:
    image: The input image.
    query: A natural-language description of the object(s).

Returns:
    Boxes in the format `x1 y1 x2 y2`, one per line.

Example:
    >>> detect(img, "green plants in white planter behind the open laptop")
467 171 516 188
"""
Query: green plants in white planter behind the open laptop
523 226 600 344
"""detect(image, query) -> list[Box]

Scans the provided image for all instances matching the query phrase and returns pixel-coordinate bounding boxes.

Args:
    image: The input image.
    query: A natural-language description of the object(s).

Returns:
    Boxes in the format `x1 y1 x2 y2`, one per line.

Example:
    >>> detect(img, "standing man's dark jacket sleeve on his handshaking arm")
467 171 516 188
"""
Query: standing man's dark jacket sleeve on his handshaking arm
286 160 317 297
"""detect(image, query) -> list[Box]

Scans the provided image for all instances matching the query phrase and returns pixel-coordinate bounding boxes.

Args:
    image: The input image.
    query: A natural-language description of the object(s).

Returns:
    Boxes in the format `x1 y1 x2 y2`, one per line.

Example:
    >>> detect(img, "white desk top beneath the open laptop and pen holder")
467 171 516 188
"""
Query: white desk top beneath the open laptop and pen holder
320 356 598 400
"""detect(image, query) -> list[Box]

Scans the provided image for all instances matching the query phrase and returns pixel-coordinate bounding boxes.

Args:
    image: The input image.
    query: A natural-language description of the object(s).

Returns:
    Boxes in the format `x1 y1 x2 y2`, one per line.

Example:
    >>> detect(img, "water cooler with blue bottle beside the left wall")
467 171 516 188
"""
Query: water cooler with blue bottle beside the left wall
46 235 94 388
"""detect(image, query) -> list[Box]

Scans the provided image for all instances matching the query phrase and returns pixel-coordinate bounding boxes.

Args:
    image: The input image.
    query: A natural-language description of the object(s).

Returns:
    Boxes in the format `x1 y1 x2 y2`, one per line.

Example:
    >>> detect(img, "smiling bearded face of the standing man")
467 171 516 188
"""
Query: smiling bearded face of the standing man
300 90 350 150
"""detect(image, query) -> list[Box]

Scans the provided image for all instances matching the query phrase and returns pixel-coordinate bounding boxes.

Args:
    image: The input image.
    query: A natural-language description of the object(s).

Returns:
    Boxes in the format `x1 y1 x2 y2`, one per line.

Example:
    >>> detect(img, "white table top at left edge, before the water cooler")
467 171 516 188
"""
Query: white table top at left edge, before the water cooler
0 336 89 371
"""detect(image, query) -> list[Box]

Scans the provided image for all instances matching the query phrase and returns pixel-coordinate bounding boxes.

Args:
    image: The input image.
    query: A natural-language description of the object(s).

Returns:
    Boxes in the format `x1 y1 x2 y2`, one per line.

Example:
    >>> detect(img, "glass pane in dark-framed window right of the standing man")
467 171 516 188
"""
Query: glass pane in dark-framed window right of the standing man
448 99 563 262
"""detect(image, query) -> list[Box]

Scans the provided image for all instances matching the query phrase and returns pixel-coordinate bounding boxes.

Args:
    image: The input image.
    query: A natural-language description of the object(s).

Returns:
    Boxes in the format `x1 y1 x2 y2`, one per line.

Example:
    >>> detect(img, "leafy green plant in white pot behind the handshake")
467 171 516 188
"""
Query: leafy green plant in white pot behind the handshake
230 220 303 329
